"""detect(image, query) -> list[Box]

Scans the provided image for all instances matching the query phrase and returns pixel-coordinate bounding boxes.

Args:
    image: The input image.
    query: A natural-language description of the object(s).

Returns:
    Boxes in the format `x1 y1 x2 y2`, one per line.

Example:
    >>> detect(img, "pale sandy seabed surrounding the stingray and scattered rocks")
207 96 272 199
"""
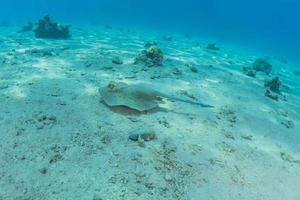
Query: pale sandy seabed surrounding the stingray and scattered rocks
0 27 300 200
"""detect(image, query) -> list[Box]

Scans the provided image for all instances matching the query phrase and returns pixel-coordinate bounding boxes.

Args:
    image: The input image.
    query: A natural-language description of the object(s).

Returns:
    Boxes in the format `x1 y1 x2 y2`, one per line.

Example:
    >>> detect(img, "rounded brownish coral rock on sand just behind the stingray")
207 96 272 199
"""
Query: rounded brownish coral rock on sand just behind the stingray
134 45 164 67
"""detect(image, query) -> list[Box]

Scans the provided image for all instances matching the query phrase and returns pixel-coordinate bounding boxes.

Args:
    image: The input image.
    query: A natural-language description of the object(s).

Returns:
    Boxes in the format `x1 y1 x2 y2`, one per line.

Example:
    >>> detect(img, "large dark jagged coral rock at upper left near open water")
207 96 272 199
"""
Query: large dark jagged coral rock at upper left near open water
33 15 71 39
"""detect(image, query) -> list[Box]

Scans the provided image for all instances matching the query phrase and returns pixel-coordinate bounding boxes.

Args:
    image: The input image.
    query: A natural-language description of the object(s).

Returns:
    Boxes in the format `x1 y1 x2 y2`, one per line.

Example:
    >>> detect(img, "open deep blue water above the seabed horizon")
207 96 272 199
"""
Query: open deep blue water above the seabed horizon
0 0 300 60
